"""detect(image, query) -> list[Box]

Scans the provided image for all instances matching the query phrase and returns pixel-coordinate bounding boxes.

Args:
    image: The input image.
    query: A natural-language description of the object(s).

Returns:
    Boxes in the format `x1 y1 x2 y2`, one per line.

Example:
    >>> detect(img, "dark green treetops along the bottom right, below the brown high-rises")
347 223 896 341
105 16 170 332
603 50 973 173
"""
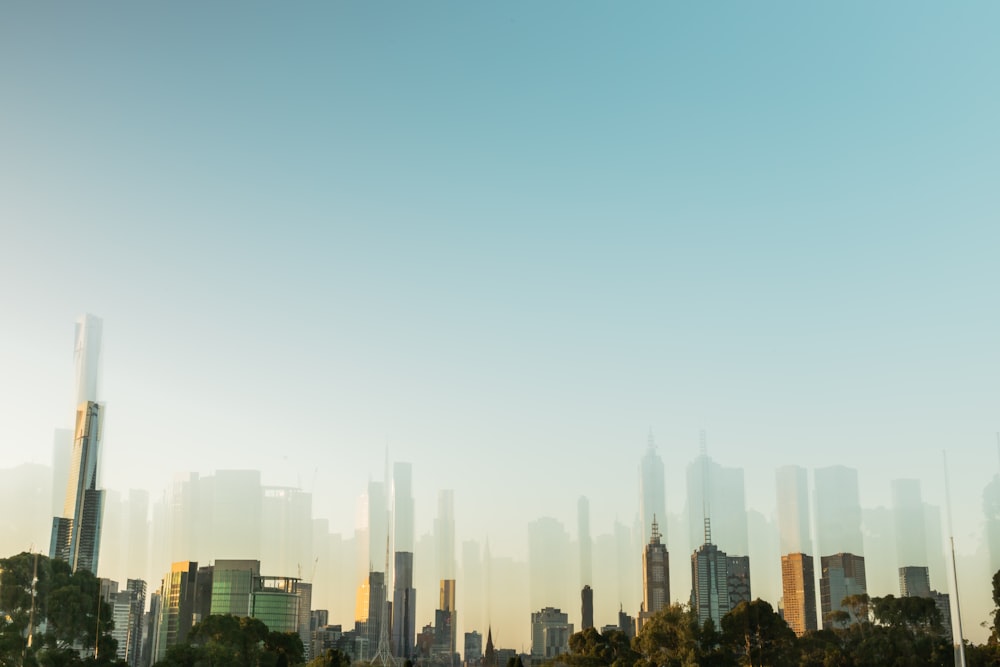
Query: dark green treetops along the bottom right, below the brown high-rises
553 596 1000 667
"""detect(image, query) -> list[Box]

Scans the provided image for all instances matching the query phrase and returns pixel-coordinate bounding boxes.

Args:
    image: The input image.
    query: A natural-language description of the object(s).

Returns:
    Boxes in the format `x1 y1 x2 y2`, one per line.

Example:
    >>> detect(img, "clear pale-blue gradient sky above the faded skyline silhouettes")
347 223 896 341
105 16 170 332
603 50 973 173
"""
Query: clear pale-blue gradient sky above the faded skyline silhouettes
0 1 1000 628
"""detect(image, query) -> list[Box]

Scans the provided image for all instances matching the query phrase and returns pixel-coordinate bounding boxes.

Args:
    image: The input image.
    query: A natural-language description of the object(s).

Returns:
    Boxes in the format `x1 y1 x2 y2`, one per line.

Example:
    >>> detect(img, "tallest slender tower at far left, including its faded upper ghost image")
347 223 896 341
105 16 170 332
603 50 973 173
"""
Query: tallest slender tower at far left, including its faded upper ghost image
49 315 104 574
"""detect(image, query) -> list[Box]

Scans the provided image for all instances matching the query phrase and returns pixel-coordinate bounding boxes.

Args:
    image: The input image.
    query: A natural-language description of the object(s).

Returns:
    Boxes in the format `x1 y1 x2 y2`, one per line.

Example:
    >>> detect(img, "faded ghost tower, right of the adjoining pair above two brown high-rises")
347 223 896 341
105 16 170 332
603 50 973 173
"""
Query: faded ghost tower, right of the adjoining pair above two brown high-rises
814 466 864 557
